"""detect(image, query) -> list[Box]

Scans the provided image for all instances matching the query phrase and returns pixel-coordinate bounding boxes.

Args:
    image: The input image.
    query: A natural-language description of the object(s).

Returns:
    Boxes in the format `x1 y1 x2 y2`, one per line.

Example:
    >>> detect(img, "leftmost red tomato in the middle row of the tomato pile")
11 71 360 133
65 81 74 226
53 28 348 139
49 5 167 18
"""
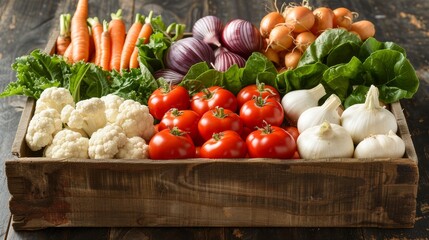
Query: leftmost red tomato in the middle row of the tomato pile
159 108 200 143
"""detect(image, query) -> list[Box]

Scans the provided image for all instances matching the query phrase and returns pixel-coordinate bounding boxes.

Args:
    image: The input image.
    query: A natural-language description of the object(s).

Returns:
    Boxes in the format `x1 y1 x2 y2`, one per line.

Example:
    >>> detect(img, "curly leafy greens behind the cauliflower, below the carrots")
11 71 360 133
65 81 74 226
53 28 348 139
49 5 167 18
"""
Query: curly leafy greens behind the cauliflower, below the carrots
0 49 158 104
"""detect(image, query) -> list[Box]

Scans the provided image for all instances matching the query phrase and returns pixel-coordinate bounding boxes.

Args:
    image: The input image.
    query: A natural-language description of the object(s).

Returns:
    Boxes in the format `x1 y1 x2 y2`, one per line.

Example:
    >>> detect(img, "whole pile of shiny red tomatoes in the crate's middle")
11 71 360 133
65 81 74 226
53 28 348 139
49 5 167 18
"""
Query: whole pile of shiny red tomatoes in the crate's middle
148 84 299 159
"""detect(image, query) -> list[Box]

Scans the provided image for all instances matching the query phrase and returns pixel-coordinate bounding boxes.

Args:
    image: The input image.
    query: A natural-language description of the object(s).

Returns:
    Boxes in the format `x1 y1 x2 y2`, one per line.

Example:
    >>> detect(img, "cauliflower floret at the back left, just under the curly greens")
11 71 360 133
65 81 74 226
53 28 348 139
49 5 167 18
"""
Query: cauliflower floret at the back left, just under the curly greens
34 87 75 114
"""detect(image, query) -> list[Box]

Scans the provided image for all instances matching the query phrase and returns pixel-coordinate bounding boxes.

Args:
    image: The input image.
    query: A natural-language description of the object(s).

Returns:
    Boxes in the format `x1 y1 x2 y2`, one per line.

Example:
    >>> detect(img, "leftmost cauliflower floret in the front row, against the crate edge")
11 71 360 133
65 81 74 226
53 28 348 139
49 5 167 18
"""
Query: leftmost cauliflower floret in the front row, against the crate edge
45 129 89 158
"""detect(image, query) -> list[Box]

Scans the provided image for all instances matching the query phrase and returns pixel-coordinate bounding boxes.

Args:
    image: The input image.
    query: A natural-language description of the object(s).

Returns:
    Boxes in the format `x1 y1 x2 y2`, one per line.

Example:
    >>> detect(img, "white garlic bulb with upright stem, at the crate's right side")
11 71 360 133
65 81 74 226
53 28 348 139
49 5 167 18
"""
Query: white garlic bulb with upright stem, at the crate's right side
341 85 398 144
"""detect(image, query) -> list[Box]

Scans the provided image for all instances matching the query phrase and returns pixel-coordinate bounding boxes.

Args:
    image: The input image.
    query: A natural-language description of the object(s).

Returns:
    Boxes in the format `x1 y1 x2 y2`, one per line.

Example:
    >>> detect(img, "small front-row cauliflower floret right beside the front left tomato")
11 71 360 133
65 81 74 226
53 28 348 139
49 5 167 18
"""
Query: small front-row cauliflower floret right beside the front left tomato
116 137 149 159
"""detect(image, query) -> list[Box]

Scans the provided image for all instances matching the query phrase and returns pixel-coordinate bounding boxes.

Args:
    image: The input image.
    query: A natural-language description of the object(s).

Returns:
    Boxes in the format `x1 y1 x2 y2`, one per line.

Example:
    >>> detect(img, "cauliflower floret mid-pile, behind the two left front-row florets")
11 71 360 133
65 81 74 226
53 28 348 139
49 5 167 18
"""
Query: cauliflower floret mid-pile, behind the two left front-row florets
61 98 107 136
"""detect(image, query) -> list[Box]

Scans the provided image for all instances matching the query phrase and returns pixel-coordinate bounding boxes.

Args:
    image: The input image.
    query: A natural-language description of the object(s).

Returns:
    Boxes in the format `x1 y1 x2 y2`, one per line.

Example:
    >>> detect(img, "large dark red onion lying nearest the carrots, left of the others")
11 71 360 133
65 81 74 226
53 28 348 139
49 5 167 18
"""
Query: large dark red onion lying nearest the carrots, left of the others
165 37 215 74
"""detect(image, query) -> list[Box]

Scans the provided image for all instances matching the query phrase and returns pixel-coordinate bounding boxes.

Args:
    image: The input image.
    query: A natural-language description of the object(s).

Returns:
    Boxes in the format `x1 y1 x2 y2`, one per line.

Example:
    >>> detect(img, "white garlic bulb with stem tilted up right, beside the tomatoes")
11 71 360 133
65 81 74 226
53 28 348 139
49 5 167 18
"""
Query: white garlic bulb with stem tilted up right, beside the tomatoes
282 84 326 126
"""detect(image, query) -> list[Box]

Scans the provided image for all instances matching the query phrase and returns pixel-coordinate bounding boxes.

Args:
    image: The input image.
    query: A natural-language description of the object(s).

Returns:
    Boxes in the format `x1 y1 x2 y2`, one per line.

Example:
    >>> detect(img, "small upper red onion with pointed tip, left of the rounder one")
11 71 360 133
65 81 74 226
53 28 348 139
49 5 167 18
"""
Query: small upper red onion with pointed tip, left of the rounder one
192 16 223 47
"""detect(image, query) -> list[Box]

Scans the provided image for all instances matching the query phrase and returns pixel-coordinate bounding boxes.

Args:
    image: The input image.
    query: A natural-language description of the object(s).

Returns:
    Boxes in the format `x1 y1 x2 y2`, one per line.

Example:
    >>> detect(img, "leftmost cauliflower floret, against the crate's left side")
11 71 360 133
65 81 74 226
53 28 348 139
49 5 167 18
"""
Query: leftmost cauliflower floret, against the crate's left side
25 108 63 151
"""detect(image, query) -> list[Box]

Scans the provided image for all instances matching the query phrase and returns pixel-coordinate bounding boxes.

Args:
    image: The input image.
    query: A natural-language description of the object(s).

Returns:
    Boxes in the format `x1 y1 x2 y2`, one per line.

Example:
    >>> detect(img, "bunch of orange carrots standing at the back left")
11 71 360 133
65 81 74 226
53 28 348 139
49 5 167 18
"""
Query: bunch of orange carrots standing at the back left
56 0 153 71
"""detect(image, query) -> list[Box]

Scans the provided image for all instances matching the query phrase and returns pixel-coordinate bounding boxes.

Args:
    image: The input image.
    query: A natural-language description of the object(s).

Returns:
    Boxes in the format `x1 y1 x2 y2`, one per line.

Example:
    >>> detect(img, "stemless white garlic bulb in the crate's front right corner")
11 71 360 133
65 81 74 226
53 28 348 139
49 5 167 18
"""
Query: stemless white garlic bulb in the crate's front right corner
354 131 405 158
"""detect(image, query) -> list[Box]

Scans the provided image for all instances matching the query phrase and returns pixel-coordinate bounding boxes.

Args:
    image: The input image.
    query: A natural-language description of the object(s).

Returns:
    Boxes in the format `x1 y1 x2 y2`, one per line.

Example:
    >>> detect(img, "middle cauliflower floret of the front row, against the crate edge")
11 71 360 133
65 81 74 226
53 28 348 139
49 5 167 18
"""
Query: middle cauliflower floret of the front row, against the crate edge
88 125 127 159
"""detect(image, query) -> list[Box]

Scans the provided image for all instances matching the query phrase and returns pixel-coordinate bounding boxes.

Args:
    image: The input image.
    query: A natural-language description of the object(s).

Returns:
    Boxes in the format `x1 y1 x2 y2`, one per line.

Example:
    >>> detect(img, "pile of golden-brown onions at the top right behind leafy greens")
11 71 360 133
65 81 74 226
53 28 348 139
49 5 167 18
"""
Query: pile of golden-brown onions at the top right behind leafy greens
259 1 375 71
